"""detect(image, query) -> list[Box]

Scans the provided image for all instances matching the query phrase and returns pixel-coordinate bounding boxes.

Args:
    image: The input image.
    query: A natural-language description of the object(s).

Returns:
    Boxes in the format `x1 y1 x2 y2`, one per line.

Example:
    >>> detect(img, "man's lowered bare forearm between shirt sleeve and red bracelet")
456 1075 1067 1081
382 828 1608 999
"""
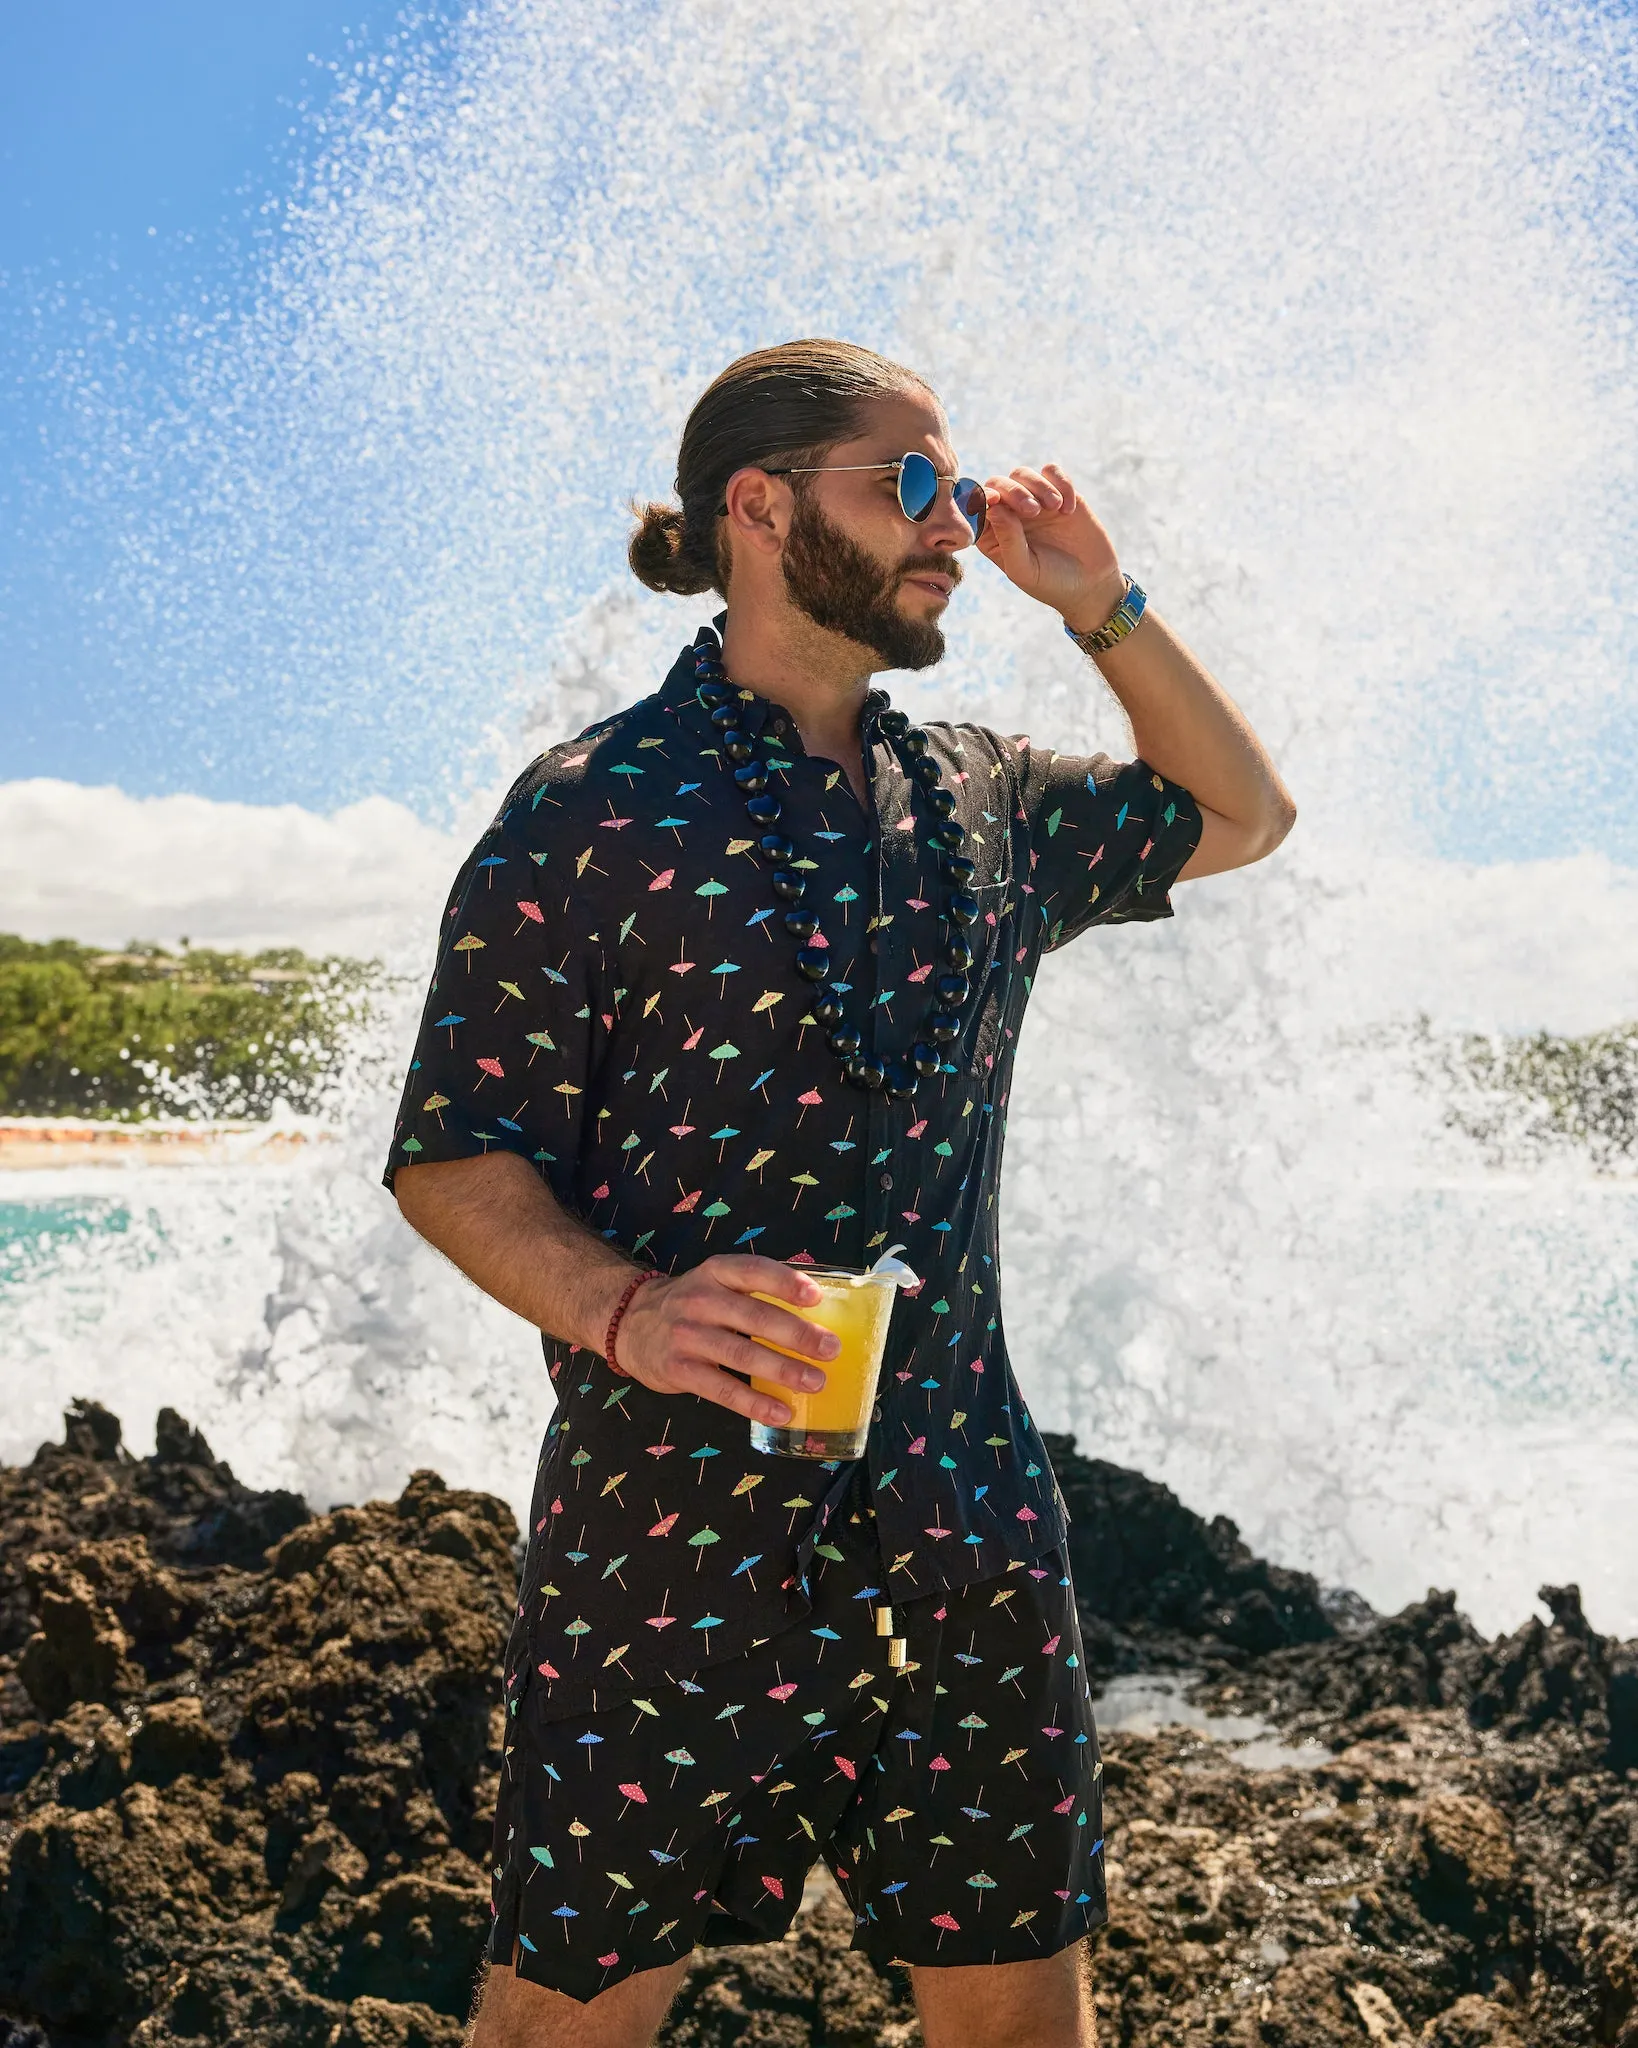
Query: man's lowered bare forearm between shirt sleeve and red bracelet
393 1151 637 1352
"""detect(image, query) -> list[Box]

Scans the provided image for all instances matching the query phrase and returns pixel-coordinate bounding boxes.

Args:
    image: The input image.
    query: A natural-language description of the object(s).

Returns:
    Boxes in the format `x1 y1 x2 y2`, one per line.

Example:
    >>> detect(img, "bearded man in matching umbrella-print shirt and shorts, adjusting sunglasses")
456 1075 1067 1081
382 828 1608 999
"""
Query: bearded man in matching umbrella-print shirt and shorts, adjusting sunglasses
387 342 1294 2048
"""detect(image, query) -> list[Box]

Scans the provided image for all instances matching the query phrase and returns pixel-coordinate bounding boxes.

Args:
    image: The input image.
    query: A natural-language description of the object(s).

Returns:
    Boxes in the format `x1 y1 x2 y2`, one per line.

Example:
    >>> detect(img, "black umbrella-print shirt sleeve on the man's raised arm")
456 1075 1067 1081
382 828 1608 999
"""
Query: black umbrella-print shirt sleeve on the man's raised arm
1022 741 1200 952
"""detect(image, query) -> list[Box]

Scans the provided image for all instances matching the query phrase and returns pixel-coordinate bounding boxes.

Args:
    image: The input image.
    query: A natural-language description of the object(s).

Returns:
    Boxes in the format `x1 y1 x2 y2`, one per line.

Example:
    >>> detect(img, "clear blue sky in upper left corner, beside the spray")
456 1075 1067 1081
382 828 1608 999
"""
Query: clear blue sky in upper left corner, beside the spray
0 0 442 786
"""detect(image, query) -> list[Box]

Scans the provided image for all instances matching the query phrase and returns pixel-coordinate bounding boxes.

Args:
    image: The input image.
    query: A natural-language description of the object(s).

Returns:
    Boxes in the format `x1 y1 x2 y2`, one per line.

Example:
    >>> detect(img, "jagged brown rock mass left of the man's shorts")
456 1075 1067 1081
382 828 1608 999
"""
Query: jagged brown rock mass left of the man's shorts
0 1405 516 2048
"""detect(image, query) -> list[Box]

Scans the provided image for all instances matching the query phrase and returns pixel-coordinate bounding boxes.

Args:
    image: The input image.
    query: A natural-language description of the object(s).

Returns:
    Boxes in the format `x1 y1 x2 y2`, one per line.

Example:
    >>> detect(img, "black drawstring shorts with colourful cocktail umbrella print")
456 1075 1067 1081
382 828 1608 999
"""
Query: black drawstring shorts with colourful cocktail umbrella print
489 1482 1106 2001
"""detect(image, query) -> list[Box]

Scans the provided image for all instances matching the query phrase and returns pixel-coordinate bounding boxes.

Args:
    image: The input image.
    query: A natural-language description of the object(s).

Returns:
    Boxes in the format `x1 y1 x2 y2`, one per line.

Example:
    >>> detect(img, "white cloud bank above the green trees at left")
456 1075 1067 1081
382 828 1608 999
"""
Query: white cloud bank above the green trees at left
0 778 481 958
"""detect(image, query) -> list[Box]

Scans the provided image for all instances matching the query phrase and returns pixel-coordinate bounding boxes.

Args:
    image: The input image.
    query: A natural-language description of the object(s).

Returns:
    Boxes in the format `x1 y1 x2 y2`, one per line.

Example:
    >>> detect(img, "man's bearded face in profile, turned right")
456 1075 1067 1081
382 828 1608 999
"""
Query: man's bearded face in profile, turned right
780 393 973 668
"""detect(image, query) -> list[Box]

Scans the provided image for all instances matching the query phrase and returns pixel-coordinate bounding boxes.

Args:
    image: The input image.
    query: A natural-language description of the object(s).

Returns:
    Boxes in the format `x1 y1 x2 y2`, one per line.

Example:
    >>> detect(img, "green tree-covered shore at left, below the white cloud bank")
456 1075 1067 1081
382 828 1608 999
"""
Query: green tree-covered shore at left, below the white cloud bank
0 934 381 1120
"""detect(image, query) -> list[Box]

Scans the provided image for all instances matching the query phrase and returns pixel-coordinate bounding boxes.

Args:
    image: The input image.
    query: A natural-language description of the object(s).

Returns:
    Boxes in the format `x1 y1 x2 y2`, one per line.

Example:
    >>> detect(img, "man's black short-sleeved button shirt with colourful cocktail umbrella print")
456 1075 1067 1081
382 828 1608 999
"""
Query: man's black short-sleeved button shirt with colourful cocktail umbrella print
385 630 1200 1714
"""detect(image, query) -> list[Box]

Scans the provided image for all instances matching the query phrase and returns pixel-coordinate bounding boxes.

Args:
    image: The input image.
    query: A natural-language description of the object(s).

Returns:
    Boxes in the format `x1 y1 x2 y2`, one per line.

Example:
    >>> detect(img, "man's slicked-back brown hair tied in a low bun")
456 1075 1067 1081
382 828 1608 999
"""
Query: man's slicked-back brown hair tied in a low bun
627 340 936 598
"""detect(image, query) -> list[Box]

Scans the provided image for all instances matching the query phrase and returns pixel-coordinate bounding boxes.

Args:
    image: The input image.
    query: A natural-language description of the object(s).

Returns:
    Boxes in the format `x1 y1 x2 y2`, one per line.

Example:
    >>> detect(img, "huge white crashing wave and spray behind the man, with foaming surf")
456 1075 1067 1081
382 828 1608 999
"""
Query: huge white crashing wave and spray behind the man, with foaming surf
0 0 1638 1632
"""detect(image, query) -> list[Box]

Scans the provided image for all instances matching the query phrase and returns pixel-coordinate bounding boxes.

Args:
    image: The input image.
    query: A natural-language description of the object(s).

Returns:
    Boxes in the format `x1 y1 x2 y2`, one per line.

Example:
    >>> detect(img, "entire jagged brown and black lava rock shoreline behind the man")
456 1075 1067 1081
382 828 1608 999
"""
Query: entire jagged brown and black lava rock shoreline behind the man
0 1403 1638 2048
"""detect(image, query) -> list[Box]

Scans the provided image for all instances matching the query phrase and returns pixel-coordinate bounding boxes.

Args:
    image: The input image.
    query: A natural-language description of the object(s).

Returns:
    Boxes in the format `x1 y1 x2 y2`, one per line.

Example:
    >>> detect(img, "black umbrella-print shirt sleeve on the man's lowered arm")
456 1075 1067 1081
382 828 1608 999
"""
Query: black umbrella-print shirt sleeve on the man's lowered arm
383 803 598 1196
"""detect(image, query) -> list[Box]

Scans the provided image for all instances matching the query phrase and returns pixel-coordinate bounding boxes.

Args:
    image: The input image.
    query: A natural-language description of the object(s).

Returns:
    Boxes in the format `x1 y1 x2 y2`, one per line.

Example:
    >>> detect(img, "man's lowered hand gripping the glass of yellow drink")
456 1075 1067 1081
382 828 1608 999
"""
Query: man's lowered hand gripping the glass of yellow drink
616 1251 842 1430
